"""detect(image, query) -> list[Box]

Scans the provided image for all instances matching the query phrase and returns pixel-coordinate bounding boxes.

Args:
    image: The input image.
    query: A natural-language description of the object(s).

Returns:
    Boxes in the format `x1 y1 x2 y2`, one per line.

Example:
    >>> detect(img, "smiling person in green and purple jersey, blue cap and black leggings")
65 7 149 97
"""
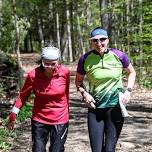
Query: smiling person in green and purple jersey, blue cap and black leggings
76 27 136 152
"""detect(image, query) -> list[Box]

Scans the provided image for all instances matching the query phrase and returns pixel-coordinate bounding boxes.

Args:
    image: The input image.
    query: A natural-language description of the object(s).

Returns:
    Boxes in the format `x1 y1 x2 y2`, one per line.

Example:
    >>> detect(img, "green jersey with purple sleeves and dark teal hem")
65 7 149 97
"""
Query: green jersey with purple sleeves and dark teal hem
77 48 130 108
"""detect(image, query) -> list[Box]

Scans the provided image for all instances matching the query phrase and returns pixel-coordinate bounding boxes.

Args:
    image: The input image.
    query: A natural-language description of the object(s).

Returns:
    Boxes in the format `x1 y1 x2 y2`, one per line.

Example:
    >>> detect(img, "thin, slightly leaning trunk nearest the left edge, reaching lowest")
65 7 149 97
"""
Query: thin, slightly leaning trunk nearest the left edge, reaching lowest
12 0 23 88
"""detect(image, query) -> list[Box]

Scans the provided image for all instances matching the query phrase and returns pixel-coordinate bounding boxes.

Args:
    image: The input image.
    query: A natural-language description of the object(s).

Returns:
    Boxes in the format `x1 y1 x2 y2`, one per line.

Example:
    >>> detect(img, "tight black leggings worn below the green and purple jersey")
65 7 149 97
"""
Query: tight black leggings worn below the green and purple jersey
88 107 124 152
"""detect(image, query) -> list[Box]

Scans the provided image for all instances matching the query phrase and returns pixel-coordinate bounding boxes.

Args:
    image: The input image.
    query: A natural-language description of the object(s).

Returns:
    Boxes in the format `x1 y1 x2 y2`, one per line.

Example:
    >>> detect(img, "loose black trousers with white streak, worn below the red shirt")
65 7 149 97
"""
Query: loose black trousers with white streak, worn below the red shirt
32 120 68 152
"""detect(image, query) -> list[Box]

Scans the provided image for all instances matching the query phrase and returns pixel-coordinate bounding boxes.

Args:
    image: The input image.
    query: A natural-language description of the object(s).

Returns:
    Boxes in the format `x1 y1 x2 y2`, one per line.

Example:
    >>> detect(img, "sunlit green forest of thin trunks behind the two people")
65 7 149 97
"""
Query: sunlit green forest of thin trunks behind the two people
0 0 152 88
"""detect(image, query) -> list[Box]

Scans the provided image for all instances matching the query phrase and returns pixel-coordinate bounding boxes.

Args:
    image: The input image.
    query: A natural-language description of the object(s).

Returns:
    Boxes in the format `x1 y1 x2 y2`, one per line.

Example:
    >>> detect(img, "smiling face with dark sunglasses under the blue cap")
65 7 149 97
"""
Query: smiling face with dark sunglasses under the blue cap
91 38 109 54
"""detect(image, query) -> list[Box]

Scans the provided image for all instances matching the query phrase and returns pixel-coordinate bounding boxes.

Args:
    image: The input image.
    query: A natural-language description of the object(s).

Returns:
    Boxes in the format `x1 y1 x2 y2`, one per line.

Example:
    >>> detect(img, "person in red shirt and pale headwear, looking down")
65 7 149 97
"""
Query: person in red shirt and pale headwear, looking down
8 46 70 152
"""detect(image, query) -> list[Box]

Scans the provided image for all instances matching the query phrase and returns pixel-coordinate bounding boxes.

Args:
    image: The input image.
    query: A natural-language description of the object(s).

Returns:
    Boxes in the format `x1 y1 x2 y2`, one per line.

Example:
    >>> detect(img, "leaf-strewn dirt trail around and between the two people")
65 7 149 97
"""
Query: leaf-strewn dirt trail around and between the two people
2 54 152 152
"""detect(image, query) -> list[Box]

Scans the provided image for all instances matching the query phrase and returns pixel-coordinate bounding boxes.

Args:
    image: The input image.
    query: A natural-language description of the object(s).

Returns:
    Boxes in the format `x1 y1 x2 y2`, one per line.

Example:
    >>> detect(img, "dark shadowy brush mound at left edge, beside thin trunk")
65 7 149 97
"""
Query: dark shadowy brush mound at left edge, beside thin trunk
0 51 18 98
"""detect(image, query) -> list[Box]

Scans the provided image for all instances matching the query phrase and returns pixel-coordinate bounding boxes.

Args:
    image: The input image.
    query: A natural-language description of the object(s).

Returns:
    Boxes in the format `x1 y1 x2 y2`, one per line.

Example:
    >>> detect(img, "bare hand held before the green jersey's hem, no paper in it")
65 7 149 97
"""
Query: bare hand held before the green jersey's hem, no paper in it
83 91 96 109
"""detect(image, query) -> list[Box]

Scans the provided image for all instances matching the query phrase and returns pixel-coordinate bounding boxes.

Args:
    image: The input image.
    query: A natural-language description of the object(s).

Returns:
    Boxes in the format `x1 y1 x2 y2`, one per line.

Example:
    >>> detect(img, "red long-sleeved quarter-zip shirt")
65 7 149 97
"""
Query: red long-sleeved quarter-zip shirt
15 65 70 124
